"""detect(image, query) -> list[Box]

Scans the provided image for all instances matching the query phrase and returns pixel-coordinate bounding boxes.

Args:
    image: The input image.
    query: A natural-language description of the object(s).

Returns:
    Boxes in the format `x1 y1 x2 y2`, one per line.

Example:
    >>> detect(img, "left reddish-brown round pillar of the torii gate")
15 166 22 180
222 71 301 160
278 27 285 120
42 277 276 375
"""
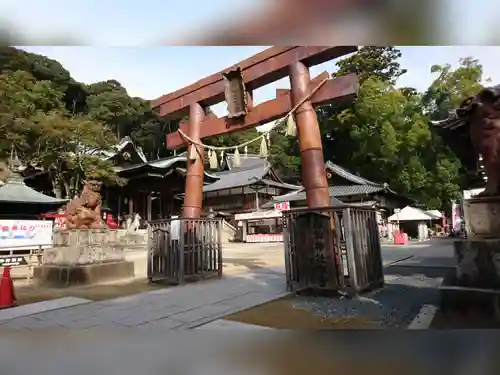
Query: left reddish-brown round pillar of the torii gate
182 103 205 219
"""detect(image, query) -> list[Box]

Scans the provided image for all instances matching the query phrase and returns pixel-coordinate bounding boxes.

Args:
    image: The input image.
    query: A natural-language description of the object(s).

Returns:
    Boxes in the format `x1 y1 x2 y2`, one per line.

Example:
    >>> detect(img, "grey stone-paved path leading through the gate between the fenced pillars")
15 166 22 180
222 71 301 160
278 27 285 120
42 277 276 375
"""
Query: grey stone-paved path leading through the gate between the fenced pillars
0 272 287 331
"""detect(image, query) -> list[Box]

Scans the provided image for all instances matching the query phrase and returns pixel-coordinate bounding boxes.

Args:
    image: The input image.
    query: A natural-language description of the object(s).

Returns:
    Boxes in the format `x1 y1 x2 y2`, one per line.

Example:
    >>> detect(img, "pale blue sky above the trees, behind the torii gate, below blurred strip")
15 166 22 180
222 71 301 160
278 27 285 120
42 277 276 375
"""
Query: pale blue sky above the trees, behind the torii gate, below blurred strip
15 46 500 114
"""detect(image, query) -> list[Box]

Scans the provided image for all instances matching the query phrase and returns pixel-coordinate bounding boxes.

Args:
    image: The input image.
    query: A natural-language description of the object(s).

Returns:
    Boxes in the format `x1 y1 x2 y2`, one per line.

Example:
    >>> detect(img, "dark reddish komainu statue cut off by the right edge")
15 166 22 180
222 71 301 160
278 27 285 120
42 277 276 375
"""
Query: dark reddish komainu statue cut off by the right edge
456 85 500 196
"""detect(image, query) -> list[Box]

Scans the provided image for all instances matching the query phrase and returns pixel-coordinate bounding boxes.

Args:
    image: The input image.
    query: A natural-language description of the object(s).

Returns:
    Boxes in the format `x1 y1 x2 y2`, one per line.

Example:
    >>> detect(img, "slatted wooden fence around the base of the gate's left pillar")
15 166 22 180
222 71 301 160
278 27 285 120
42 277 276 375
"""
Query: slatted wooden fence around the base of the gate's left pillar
148 218 223 284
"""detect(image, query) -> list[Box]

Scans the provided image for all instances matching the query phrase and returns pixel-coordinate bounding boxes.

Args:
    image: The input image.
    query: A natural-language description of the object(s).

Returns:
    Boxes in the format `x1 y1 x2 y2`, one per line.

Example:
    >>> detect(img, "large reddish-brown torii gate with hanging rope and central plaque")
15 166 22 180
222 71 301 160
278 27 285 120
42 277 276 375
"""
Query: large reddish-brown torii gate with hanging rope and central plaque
151 46 358 219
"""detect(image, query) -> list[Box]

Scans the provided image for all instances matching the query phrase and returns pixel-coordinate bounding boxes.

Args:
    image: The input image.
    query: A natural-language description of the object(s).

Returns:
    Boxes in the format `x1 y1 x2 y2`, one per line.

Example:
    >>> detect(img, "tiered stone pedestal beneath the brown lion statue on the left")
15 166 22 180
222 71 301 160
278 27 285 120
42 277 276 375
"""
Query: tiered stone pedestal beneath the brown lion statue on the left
33 229 139 286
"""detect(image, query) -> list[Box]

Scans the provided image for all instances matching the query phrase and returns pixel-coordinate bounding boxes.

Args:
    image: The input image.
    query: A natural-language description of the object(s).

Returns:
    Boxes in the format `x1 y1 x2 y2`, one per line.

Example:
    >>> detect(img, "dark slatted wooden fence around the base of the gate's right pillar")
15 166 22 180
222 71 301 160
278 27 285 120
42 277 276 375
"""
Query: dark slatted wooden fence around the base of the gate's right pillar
283 205 384 294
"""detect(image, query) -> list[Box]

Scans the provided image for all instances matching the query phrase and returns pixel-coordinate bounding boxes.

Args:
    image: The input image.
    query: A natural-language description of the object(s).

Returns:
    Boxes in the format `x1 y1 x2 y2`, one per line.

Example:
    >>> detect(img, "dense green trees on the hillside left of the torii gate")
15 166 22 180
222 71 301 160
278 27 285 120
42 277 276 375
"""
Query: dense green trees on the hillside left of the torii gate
0 47 168 197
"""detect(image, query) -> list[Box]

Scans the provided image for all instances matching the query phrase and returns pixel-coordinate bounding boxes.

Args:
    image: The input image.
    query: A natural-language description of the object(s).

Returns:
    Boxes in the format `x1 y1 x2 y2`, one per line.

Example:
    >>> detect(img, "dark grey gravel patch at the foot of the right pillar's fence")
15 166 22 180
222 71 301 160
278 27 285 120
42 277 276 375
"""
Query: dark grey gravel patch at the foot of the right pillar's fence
294 275 442 328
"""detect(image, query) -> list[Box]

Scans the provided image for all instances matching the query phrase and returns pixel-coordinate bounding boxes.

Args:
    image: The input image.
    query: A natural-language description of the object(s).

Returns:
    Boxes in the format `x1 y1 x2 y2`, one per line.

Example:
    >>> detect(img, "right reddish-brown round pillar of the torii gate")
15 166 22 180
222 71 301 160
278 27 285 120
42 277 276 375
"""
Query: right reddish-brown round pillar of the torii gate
290 62 331 208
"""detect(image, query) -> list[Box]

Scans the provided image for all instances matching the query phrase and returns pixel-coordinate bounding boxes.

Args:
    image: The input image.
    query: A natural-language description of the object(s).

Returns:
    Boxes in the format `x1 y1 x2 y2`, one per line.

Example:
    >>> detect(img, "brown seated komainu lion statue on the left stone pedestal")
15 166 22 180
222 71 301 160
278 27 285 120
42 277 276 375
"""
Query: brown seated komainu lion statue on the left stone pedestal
65 180 106 229
